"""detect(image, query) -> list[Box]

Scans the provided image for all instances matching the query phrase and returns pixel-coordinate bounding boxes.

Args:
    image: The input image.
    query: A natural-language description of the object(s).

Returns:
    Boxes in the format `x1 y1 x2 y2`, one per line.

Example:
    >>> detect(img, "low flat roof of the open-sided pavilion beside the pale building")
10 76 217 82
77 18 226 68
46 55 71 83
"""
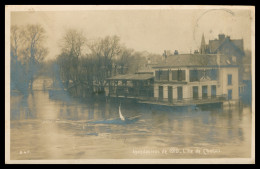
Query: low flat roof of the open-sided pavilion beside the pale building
107 74 154 80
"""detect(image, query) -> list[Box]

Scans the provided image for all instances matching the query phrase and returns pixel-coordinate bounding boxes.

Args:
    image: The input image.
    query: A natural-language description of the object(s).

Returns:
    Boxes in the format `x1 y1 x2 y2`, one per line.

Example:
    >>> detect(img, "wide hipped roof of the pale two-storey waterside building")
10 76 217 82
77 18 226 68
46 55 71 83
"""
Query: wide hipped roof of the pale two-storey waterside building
153 54 240 68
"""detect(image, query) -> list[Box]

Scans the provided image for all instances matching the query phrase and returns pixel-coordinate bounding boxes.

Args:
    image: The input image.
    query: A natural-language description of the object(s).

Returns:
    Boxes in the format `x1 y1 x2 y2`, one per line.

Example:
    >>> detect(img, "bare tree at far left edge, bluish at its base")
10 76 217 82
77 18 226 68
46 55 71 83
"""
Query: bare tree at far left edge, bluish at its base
10 25 48 92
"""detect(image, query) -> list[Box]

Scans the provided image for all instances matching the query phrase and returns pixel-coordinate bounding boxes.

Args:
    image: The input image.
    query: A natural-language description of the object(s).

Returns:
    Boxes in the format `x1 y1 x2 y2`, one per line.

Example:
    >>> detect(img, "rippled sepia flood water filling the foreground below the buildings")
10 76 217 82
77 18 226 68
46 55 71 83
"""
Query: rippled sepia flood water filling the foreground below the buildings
10 77 252 160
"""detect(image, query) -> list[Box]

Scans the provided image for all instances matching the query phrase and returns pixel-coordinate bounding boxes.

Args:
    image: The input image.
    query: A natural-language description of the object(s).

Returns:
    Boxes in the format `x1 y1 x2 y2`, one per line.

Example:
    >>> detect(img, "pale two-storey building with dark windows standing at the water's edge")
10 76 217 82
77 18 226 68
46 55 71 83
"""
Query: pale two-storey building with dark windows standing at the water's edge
154 54 239 104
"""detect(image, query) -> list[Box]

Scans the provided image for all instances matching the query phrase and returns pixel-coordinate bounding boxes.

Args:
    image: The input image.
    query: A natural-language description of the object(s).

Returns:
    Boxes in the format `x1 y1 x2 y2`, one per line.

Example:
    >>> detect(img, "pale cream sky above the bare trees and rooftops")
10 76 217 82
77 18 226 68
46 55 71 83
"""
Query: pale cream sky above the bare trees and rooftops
11 9 251 59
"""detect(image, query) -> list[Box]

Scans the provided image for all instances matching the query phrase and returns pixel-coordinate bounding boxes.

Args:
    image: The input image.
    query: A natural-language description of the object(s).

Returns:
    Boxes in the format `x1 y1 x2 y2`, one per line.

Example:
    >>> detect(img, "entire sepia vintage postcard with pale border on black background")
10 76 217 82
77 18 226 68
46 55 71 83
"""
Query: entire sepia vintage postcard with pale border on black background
5 5 255 164
